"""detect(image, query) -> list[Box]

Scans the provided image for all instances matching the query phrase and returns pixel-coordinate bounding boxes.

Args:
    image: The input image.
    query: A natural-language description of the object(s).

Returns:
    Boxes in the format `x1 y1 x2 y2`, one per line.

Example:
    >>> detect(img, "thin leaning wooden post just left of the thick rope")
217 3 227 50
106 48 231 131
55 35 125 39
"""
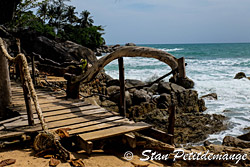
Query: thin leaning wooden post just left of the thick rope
19 63 35 126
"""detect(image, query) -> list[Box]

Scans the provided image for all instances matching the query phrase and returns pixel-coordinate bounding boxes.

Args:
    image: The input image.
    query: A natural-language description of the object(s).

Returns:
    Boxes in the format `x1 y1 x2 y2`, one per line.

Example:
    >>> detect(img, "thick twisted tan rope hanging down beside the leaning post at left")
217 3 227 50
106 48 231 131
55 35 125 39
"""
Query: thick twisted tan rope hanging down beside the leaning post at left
0 38 48 131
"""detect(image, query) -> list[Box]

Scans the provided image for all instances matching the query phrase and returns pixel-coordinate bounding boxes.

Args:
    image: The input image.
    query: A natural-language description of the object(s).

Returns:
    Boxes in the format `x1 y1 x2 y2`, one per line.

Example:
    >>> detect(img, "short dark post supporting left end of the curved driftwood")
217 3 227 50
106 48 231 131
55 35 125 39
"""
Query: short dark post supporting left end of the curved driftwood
64 73 80 99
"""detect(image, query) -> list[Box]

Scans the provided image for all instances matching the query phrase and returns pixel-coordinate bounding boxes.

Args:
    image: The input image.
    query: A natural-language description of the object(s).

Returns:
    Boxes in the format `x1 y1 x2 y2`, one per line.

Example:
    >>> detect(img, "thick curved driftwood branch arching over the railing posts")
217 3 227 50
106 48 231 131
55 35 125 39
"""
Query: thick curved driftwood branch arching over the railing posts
71 46 178 83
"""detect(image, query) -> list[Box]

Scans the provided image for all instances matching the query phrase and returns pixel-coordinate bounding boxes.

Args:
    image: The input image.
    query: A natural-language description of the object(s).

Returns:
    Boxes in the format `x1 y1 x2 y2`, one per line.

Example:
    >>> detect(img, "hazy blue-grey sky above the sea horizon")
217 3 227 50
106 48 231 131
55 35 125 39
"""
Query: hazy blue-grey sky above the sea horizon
67 0 250 44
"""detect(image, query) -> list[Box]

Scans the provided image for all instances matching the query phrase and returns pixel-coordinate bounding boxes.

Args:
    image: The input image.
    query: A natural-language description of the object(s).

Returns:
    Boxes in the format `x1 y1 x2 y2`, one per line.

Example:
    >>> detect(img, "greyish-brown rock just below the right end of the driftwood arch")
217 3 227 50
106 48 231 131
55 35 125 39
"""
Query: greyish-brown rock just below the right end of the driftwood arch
158 82 186 94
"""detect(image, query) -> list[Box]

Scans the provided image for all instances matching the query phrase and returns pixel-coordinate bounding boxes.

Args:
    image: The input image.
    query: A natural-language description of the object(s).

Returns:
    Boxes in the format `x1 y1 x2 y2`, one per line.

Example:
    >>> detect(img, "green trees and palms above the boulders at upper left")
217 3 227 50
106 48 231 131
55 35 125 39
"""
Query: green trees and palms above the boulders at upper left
9 0 105 49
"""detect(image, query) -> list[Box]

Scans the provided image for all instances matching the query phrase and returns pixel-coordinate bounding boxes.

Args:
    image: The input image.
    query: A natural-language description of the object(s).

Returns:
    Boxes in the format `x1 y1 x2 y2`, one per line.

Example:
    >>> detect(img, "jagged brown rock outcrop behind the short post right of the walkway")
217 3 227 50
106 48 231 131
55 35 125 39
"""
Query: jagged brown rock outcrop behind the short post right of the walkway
129 102 226 144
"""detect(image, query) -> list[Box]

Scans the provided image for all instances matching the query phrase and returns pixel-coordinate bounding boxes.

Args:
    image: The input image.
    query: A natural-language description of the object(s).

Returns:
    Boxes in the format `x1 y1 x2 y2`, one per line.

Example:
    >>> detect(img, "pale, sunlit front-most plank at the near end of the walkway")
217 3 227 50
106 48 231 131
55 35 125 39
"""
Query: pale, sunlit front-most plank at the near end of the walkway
79 122 151 141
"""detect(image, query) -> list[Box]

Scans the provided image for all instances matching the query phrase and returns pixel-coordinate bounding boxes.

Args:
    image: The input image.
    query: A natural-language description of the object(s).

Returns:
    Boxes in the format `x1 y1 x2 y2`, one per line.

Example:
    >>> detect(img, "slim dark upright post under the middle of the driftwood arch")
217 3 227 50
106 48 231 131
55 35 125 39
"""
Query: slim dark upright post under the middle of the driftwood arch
118 57 126 117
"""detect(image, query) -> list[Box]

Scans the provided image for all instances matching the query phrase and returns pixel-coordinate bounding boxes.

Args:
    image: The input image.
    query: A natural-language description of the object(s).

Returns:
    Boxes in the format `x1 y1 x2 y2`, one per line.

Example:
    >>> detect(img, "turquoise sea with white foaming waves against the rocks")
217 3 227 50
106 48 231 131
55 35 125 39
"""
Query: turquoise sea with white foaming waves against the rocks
105 43 250 143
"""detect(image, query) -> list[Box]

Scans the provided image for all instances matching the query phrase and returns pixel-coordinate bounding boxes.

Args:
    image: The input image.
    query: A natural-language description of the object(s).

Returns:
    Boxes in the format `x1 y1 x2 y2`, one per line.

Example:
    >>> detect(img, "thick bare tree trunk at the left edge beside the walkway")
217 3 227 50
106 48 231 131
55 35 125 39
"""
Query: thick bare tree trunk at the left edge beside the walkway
0 47 11 117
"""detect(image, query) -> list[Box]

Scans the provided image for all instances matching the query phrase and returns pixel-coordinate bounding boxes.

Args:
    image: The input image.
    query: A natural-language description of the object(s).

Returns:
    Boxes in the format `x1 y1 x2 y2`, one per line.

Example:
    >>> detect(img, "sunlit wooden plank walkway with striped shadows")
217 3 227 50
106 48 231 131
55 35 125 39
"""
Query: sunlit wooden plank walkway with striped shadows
0 82 151 153
